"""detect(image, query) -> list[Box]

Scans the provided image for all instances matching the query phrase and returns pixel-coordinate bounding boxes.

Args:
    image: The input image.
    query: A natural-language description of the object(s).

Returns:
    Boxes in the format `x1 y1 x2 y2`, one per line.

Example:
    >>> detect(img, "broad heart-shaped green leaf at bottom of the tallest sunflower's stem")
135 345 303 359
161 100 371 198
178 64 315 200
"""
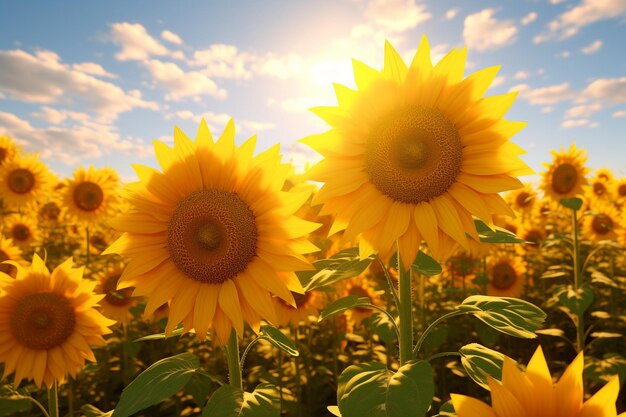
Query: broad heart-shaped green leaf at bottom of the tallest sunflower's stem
337 361 434 417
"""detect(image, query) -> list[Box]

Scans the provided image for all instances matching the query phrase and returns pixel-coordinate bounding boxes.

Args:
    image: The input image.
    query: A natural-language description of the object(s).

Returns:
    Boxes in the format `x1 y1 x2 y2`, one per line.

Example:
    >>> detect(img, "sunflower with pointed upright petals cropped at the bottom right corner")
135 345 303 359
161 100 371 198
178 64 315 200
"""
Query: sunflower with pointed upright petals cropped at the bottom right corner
451 346 626 417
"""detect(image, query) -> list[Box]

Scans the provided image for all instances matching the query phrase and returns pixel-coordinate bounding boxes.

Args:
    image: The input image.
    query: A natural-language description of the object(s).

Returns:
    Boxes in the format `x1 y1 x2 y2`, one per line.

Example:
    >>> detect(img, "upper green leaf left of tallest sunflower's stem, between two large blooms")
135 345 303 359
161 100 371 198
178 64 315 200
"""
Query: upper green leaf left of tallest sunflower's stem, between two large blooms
296 248 374 291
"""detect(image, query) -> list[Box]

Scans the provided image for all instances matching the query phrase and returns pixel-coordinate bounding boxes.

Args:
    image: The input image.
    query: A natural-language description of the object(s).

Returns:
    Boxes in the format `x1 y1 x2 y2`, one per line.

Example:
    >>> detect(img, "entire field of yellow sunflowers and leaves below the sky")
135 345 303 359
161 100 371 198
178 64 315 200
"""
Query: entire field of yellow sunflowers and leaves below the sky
0 37 626 417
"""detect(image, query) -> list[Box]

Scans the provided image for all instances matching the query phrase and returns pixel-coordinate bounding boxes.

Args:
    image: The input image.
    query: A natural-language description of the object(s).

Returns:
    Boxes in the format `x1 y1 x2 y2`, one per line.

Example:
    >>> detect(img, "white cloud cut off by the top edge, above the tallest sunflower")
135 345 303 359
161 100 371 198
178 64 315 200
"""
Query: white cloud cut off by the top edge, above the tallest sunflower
365 0 432 32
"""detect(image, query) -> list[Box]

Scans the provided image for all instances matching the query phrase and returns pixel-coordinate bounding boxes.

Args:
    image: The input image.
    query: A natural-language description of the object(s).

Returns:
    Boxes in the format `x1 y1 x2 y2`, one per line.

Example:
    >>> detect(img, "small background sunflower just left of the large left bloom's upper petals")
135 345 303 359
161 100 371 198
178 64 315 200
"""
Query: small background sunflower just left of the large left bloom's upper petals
61 166 119 226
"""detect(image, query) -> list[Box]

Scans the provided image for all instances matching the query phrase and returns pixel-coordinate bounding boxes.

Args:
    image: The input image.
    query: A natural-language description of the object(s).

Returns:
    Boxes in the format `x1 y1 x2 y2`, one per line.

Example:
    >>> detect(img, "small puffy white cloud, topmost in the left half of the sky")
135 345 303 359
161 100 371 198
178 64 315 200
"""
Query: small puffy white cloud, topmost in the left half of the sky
111 22 168 61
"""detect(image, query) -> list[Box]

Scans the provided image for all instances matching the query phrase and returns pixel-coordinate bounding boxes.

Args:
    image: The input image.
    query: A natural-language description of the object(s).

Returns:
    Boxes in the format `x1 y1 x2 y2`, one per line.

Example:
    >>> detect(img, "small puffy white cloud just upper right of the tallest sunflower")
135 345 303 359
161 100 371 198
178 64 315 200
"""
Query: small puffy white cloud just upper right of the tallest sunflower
463 8 517 51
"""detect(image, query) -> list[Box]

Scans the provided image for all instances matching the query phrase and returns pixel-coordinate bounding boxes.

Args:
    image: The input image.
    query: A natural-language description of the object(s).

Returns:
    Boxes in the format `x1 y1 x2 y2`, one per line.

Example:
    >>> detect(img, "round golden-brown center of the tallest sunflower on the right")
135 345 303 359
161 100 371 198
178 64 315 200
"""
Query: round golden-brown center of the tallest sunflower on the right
366 106 463 204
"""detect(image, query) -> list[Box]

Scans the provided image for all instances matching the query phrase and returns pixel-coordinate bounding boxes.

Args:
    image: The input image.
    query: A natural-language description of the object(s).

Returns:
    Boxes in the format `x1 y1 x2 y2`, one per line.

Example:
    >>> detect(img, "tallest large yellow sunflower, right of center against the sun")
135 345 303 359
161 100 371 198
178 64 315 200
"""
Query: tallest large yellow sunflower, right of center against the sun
302 37 532 268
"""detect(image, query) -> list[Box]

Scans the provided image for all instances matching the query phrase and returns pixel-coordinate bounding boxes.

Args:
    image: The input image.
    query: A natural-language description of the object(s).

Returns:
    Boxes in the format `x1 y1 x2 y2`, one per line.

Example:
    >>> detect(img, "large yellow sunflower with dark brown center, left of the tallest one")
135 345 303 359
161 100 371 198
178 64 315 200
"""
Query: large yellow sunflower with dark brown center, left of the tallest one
103 120 318 344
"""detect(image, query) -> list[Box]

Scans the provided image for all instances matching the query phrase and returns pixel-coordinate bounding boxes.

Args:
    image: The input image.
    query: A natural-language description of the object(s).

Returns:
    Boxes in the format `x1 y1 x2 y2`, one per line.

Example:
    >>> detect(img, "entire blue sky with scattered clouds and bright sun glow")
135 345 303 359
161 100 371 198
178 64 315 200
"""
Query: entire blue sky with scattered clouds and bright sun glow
0 0 626 180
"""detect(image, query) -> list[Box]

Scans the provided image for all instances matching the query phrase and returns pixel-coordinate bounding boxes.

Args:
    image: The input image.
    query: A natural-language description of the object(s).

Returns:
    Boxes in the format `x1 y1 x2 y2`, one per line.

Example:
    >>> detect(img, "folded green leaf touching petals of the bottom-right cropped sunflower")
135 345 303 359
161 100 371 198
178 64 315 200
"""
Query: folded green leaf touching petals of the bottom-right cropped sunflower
459 343 504 390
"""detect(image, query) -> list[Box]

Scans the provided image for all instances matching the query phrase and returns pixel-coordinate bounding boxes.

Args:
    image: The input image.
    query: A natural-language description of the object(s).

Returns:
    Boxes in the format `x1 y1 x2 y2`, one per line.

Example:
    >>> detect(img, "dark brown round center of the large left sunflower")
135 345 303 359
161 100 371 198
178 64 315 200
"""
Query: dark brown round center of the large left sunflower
167 189 258 284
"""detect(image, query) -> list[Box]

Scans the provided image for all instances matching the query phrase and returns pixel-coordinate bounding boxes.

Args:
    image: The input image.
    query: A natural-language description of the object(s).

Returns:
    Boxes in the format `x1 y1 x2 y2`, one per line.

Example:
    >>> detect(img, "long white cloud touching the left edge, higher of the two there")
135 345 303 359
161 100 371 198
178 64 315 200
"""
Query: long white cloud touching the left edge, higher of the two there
0 50 158 120
